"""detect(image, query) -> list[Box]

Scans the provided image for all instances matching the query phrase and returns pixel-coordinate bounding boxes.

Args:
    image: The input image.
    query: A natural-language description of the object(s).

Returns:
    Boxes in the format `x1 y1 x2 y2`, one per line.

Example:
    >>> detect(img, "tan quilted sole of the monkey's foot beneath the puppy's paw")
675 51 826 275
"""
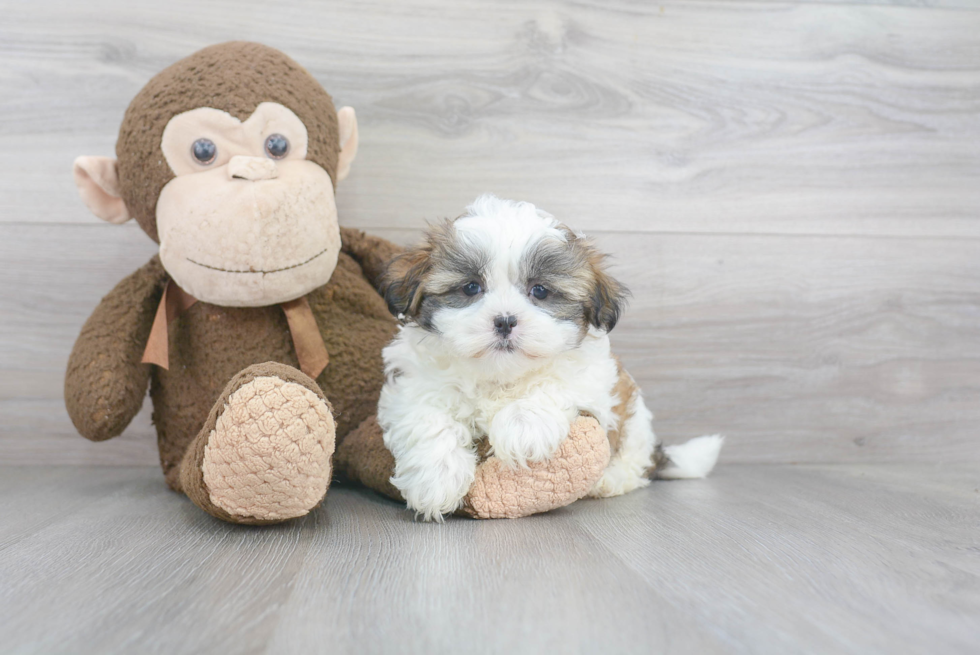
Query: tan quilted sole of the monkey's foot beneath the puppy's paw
459 416 609 519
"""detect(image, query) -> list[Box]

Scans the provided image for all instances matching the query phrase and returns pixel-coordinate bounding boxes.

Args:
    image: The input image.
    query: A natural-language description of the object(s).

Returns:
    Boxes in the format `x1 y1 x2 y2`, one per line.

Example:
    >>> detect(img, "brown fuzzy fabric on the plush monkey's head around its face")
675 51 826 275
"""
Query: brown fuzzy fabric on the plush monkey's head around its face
116 41 339 241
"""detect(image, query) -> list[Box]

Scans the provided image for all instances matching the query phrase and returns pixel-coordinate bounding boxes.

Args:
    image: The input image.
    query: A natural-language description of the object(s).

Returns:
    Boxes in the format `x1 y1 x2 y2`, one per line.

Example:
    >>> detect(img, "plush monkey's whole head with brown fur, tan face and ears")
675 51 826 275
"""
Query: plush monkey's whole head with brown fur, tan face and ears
74 42 357 307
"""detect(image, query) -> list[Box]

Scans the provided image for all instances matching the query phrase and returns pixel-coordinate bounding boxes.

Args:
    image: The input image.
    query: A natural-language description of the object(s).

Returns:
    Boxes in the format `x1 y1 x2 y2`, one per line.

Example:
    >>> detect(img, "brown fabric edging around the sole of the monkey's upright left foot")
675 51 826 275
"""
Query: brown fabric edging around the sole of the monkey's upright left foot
177 362 330 525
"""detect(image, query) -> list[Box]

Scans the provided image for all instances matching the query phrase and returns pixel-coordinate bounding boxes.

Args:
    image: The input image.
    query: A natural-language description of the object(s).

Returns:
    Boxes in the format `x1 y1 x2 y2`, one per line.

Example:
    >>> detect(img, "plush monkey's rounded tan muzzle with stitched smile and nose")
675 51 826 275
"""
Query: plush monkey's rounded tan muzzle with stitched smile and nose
157 156 340 307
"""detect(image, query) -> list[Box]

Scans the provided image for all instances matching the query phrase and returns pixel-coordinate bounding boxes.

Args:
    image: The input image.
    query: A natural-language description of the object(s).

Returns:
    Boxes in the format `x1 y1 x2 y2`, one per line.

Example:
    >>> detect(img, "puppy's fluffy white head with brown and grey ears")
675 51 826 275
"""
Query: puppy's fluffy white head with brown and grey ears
383 195 628 361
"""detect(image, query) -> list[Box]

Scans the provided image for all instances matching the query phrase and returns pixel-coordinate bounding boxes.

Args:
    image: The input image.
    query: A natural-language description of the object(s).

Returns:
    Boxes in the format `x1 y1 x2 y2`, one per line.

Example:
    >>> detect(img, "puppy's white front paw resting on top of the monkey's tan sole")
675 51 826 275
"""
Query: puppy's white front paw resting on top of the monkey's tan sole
488 403 571 468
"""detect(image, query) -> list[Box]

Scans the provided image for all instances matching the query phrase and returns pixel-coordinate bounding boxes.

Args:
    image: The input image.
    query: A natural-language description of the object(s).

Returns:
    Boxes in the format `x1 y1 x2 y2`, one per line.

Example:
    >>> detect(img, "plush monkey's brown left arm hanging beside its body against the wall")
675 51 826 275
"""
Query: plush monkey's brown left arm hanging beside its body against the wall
65 256 167 441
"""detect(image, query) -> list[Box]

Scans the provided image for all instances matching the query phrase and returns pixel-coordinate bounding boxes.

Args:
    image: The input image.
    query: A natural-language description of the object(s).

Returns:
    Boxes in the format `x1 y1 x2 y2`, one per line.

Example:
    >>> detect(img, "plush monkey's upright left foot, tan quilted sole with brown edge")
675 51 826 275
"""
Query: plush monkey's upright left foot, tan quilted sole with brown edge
180 362 335 524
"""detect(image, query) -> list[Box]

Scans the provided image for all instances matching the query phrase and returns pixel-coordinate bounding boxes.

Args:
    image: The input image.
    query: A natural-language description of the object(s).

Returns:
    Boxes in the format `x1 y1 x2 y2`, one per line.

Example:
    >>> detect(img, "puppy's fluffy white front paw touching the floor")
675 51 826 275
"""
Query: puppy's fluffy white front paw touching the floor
391 438 476 523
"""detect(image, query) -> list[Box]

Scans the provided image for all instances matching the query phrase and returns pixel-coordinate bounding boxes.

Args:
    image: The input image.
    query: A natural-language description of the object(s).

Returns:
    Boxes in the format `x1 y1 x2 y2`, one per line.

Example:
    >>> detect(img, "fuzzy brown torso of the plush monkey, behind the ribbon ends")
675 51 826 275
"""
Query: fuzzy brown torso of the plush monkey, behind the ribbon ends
150 253 396 487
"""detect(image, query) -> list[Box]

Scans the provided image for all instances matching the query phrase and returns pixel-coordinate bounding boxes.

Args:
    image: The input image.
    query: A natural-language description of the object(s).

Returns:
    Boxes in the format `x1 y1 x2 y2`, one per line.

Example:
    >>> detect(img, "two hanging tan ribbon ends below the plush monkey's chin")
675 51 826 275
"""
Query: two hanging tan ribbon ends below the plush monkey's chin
142 280 330 380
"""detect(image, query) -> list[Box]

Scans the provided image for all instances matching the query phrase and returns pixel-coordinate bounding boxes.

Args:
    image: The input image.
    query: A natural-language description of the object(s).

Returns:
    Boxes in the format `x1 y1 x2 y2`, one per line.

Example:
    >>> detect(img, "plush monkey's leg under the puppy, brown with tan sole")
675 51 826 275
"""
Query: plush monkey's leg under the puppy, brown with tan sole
335 416 609 519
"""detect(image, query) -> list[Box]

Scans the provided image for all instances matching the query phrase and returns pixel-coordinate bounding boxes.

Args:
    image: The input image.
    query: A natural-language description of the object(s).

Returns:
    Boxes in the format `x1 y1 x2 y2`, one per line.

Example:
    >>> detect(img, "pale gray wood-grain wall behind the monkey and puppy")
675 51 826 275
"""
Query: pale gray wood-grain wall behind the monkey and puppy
0 0 980 472
